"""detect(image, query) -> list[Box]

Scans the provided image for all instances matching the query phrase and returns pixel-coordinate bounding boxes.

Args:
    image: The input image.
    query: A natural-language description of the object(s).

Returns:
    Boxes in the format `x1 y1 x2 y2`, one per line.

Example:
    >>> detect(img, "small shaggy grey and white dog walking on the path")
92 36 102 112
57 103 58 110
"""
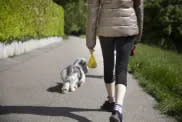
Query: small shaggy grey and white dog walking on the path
60 58 88 94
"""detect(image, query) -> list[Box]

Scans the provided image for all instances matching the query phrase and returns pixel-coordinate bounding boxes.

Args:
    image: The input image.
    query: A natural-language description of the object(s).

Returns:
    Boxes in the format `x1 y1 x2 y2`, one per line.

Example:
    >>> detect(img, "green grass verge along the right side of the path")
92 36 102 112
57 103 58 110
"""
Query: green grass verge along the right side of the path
129 44 182 121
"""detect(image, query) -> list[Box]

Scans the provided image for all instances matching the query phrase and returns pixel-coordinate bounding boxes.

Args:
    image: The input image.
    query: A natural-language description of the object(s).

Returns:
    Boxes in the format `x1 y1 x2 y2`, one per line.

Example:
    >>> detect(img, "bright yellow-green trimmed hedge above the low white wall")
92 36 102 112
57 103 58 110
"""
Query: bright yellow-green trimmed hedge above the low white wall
0 0 64 43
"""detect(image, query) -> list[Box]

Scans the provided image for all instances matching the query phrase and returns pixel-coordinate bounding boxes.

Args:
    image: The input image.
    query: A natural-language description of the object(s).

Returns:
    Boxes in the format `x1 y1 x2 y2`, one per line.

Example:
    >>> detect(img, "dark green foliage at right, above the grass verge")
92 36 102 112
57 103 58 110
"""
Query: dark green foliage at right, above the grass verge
143 0 182 52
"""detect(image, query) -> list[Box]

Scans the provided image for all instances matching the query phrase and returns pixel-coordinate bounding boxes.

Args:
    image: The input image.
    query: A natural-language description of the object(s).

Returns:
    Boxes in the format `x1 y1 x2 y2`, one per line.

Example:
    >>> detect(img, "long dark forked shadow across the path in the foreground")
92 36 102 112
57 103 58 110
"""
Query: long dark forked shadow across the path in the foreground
0 106 101 122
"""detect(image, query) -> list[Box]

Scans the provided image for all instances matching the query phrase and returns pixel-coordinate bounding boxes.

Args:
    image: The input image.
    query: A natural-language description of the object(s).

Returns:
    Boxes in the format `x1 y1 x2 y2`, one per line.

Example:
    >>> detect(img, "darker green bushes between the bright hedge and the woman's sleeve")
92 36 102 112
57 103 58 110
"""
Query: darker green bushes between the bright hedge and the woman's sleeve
54 0 87 35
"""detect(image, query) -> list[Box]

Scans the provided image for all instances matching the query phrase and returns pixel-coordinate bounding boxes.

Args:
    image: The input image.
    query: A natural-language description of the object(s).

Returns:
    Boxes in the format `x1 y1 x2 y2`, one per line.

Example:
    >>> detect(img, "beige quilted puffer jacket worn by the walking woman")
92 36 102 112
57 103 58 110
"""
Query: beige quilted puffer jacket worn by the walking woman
86 0 143 49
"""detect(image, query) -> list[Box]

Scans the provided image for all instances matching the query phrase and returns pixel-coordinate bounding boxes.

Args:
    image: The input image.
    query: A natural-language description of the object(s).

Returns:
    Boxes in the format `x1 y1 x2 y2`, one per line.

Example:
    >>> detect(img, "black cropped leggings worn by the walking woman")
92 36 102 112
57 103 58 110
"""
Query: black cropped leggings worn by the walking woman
99 36 133 86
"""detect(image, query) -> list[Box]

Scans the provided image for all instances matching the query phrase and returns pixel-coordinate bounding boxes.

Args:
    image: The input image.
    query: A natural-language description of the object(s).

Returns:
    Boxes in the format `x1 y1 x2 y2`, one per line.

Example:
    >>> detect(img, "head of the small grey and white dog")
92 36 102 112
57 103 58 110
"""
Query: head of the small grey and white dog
73 58 88 74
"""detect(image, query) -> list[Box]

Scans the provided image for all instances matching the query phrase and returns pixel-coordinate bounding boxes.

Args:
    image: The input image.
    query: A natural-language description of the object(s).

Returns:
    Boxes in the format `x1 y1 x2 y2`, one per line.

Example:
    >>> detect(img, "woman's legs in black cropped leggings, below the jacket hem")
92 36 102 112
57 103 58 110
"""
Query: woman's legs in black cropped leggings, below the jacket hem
100 36 134 122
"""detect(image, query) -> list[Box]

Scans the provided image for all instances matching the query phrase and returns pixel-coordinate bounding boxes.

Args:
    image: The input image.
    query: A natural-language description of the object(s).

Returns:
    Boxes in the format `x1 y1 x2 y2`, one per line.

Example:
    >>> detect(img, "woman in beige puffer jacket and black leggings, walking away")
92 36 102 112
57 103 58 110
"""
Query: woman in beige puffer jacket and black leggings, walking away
86 0 143 122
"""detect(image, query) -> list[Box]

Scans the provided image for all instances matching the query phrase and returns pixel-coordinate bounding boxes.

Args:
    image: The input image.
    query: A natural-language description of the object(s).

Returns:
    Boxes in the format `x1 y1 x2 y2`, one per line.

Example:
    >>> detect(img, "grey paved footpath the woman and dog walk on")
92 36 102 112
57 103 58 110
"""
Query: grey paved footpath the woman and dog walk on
0 37 175 122
